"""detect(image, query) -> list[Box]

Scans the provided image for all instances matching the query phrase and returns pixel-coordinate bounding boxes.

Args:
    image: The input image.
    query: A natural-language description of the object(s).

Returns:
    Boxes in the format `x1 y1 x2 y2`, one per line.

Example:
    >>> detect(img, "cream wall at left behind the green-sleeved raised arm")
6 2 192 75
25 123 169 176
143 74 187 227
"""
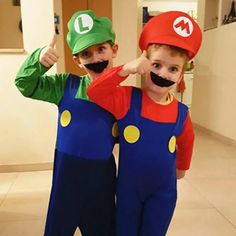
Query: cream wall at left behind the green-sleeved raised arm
0 0 57 165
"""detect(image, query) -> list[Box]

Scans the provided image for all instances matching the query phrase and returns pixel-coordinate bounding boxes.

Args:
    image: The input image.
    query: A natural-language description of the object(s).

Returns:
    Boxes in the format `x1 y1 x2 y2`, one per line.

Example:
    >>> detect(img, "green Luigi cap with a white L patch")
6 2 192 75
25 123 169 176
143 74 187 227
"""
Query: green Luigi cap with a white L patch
66 10 115 55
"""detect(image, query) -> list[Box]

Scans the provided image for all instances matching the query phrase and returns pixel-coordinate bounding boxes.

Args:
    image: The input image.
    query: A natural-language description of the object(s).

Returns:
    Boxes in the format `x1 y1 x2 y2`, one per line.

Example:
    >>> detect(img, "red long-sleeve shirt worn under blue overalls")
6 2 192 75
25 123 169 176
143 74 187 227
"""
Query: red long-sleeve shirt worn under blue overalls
87 66 194 170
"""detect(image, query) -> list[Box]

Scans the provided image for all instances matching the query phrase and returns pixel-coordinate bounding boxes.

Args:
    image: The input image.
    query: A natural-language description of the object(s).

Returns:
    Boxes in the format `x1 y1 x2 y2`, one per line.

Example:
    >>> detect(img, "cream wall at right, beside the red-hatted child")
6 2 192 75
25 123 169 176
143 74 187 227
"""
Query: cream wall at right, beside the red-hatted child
192 23 236 141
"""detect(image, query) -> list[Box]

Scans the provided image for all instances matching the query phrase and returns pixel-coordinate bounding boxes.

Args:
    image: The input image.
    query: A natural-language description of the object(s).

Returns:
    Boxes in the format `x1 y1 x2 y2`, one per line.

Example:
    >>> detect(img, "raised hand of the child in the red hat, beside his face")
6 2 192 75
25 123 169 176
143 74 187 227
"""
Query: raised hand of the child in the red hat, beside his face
119 50 151 76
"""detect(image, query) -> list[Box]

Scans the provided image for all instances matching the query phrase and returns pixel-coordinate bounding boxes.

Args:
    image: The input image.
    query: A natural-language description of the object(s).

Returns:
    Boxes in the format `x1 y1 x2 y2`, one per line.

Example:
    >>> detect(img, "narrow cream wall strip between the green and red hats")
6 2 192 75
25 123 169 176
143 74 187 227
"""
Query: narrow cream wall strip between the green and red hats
112 0 142 86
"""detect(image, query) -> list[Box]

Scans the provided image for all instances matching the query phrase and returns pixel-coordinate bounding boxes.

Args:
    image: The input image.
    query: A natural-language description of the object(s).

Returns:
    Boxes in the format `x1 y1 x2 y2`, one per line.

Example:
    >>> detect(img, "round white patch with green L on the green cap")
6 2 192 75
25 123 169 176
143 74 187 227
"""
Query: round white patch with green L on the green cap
74 14 93 34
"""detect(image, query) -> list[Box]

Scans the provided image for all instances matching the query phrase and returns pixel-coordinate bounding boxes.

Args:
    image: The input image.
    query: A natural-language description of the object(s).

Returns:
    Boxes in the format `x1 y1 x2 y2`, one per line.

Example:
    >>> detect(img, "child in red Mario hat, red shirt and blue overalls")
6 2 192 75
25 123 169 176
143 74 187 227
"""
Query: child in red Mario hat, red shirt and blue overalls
87 11 202 236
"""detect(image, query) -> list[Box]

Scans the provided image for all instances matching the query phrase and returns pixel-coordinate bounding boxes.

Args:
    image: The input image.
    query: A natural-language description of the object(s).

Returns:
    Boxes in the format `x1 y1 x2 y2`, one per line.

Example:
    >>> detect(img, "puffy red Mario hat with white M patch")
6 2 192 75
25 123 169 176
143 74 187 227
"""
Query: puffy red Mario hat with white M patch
139 11 202 60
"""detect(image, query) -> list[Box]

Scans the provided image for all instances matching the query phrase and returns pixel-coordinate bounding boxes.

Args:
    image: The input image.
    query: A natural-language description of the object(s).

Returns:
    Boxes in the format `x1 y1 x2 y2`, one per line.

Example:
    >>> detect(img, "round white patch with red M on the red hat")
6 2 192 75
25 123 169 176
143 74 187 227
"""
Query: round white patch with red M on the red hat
173 16 193 37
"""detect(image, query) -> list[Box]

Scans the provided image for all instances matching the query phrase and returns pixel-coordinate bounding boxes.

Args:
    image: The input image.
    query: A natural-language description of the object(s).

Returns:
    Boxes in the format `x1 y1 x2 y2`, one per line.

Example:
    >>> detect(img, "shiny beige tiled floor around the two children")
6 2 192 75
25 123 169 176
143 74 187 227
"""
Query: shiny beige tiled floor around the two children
0 131 236 236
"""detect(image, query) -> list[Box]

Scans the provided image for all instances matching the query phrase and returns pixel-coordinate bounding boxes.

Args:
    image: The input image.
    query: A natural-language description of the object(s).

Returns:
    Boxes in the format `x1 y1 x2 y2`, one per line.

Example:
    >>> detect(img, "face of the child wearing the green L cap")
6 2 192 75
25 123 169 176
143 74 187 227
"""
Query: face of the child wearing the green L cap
74 42 118 79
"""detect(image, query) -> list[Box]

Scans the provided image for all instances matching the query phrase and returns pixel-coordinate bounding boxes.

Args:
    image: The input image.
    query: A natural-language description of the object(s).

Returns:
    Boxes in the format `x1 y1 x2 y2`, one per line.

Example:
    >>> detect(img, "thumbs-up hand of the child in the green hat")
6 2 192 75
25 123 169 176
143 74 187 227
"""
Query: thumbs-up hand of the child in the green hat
39 34 59 67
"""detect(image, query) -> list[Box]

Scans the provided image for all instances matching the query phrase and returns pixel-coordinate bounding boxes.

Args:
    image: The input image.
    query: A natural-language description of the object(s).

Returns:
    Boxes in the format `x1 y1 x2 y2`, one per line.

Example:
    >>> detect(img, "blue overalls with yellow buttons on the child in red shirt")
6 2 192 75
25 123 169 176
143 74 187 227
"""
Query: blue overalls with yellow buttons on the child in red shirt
116 88 187 236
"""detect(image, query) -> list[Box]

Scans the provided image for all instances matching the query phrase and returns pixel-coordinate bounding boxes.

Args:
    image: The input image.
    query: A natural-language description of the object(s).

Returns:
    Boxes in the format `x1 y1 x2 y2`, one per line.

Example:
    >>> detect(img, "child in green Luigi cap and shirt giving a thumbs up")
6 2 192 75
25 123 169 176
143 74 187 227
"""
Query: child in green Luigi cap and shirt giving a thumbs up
15 10 117 236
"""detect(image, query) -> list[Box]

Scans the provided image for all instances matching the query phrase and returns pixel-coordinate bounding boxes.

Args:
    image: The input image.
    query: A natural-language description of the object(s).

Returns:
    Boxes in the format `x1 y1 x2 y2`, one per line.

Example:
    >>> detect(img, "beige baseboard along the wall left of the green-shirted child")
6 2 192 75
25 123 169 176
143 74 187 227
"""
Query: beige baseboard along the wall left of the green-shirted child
0 162 53 173
